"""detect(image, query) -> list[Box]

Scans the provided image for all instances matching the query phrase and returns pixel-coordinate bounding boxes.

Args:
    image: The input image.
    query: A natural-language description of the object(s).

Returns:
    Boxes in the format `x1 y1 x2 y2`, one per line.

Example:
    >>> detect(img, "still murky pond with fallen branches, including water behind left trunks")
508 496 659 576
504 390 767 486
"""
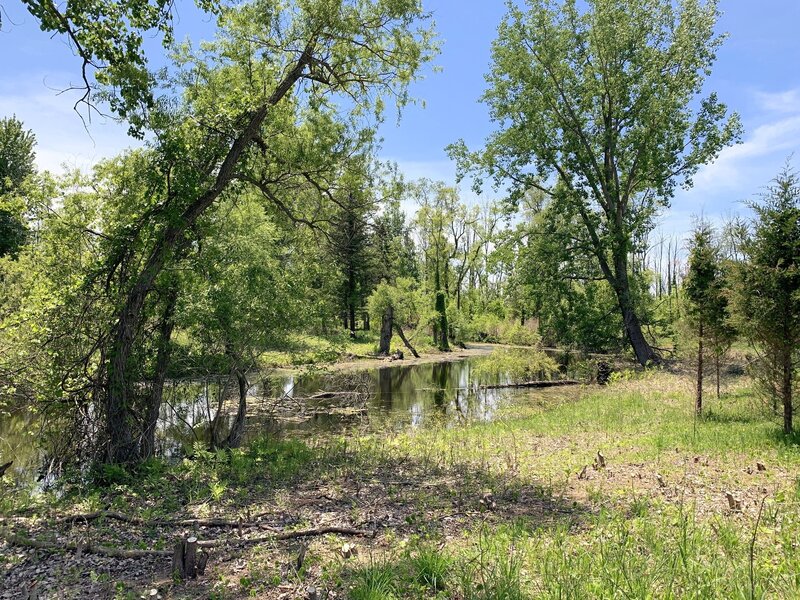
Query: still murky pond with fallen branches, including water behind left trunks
0 357 588 481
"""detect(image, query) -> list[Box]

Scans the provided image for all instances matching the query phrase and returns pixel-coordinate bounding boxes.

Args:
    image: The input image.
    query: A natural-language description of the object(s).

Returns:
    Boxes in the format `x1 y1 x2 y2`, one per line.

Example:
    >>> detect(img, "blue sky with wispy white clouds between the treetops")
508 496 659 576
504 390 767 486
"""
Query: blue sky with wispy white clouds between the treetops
0 0 800 233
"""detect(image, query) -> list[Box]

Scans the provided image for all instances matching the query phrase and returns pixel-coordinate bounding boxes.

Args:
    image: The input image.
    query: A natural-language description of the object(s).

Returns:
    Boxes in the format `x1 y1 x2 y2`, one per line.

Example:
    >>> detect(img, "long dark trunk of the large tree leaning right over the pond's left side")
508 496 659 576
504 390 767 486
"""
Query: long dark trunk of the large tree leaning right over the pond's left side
105 50 311 463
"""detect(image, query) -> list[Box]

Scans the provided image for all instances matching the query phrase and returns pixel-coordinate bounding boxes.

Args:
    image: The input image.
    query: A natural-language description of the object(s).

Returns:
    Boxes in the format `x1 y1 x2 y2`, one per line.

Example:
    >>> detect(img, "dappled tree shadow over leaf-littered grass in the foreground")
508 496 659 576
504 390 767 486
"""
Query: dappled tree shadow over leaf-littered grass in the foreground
17 438 589 598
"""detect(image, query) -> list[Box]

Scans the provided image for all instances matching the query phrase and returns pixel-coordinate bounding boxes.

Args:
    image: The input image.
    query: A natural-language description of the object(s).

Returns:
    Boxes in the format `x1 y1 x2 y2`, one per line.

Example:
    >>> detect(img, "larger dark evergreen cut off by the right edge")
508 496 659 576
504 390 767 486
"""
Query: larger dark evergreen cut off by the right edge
731 166 800 434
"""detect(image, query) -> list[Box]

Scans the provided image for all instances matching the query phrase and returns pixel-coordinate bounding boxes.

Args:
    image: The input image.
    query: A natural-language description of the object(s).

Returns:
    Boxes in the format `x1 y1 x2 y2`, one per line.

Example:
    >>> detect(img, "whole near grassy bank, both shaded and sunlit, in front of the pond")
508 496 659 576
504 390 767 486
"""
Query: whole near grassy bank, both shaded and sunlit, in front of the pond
0 373 800 600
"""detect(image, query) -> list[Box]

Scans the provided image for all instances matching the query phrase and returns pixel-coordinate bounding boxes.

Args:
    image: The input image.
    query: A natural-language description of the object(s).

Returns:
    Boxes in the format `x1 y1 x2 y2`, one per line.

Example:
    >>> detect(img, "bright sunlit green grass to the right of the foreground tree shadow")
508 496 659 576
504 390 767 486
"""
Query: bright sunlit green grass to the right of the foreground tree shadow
328 373 800 600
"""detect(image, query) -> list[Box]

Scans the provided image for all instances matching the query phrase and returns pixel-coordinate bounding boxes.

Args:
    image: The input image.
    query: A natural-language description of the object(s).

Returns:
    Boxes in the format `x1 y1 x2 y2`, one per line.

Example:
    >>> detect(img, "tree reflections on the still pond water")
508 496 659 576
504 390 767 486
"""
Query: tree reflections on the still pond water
160 359 514 455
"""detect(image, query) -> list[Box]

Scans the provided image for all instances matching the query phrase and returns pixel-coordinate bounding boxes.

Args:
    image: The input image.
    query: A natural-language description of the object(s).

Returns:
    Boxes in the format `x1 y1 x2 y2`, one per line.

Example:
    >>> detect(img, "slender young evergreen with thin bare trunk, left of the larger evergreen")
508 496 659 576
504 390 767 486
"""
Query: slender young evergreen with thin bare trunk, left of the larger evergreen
683 221 728 415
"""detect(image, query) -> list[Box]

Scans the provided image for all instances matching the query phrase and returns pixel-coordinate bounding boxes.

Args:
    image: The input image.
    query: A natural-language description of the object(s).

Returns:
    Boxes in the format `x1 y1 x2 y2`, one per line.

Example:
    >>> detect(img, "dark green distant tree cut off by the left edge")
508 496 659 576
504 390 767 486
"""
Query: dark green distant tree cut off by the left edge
0 117 36 257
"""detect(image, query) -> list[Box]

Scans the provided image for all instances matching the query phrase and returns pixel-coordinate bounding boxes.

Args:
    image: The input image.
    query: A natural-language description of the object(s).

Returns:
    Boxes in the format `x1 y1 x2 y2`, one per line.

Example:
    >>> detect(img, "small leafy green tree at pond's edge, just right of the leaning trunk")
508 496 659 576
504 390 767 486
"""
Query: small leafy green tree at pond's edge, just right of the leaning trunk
178 192 301 448
